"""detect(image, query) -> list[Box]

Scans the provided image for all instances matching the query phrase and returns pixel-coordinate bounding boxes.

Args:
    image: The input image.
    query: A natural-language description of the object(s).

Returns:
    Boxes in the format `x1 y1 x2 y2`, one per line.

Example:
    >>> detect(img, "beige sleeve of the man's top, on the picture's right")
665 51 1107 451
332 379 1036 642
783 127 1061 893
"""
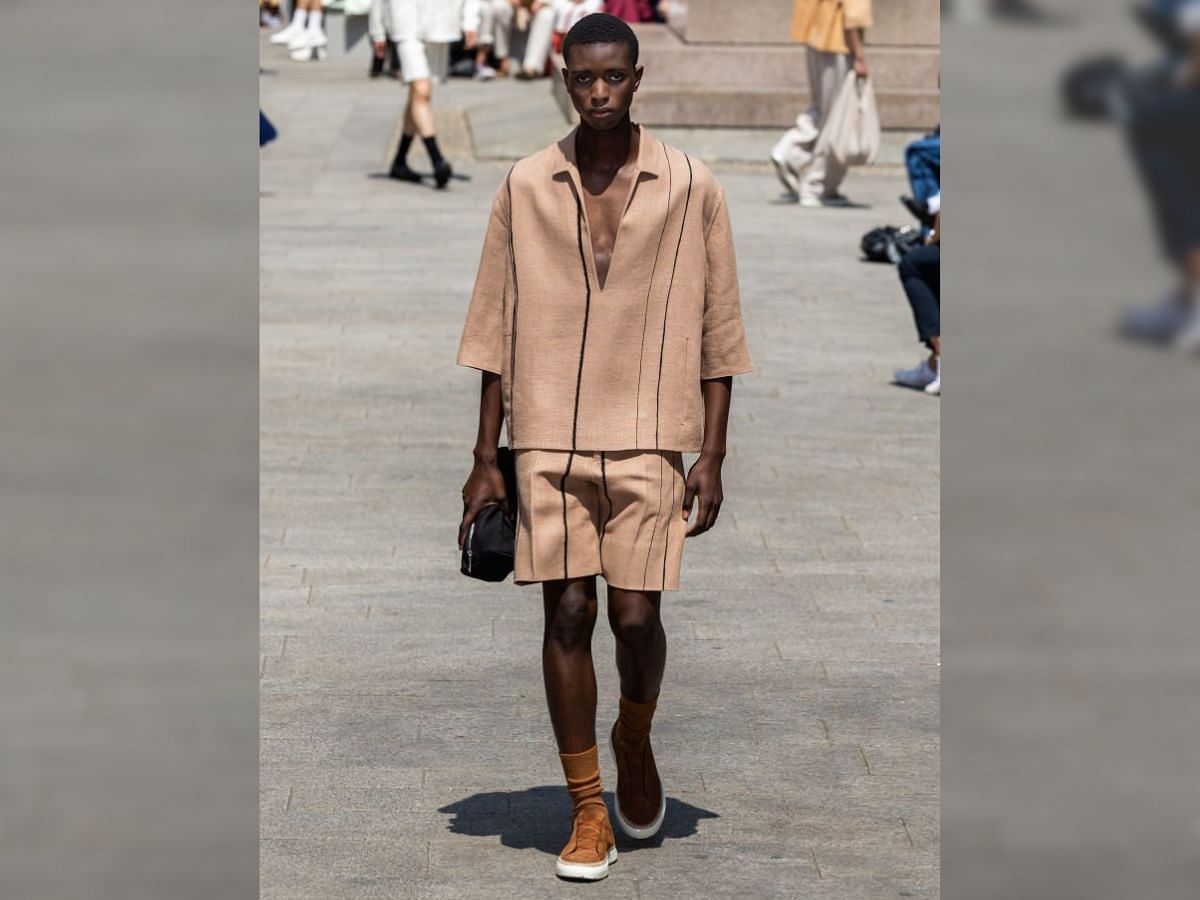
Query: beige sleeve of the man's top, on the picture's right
700 188 754 380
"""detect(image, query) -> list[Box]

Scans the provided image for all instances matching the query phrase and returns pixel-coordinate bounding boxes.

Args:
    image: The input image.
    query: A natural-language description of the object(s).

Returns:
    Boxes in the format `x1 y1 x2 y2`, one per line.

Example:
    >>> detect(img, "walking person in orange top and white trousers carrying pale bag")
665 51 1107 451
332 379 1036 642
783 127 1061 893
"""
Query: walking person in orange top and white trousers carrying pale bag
770 0 872 206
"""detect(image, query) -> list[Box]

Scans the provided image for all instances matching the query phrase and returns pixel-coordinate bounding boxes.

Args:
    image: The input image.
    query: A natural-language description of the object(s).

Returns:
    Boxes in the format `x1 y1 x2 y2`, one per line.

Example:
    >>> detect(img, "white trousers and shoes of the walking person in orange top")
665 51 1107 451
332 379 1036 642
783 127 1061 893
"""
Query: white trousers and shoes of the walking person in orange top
773 47 853 197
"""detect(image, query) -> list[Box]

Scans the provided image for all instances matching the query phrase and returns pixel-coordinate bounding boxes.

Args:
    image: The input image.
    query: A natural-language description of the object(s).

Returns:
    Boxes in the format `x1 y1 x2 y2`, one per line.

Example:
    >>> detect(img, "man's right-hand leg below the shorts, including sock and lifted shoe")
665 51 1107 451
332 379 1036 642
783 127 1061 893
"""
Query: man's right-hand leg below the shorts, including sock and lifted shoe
608 586 667 839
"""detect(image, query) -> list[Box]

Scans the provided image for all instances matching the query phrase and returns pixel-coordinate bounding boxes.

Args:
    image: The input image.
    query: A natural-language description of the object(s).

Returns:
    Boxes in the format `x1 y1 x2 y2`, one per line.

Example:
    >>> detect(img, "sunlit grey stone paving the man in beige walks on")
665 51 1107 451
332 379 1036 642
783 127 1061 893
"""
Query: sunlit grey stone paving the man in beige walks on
262 44 936 900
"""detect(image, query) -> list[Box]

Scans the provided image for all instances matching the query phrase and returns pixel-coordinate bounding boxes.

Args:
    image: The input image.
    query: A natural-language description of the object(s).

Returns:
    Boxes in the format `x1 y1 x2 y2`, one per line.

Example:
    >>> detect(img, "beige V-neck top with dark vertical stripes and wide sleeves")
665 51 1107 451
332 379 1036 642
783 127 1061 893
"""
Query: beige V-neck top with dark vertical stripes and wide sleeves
458 127 752 452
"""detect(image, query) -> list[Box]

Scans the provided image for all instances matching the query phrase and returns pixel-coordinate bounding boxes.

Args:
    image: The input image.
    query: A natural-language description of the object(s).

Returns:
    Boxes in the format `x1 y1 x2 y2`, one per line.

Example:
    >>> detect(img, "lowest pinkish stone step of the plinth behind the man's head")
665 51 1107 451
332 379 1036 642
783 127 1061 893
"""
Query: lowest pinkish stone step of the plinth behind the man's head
628 83 940 130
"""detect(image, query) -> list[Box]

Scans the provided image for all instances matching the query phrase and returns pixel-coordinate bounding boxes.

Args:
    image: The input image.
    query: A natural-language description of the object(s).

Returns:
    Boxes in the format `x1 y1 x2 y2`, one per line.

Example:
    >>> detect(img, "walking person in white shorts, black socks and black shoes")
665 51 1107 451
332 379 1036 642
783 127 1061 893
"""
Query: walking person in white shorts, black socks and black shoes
388 0 479 188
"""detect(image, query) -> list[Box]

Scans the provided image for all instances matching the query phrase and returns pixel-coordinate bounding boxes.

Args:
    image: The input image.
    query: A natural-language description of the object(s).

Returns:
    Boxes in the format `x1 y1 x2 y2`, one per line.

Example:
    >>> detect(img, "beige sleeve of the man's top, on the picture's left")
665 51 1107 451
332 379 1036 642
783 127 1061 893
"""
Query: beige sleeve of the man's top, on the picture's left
457 180 510 374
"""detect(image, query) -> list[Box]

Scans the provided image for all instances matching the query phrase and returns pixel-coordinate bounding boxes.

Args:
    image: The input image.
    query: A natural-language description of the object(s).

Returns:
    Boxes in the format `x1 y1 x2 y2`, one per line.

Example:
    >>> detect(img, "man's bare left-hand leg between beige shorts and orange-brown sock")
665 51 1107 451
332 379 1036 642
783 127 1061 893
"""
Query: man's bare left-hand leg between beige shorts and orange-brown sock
541 576 596 754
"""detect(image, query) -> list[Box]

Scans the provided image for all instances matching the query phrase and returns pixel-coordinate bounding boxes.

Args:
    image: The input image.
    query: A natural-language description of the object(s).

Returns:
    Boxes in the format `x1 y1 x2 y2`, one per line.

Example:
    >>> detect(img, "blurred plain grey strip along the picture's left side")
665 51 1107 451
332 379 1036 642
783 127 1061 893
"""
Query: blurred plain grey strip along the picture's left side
0 1 258 900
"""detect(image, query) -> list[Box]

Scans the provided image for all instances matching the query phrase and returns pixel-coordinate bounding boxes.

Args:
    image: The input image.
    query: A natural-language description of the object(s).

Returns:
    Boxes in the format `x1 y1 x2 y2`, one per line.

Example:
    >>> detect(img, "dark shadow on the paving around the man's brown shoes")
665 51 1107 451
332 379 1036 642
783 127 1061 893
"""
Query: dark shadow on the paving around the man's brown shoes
438 785 718 854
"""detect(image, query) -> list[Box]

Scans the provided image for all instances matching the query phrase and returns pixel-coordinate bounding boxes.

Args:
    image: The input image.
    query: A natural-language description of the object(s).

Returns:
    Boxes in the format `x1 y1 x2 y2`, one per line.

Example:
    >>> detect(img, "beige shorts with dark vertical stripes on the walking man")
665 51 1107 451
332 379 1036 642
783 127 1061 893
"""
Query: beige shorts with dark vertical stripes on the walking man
514 450 688 590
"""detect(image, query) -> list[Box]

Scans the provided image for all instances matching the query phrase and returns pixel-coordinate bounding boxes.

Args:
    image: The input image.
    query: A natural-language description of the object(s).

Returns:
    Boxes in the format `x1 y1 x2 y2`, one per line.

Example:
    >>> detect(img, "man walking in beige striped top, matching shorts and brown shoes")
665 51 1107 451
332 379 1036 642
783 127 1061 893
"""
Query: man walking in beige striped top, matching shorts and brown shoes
458 13 751 880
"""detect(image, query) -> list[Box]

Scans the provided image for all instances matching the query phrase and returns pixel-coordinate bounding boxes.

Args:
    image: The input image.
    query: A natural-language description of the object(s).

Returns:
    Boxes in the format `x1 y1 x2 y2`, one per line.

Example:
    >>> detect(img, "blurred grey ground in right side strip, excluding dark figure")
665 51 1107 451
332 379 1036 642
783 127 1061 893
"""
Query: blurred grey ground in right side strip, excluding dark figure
942 0 1200 898
